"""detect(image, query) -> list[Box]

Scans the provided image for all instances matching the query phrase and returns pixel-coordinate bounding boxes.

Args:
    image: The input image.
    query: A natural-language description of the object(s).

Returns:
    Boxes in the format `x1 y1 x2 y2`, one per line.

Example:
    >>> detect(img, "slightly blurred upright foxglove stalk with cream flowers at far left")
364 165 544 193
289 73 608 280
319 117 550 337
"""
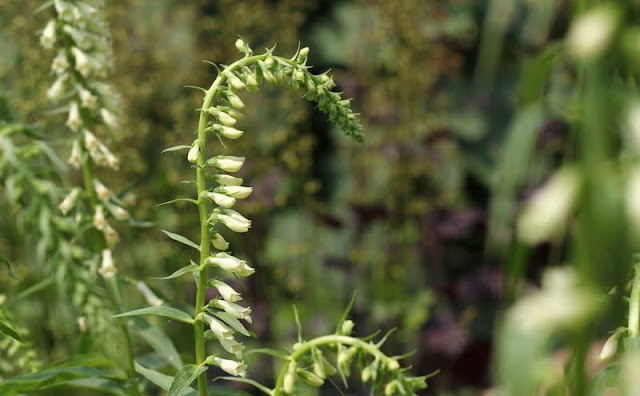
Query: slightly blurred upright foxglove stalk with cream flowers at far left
40 0 138 394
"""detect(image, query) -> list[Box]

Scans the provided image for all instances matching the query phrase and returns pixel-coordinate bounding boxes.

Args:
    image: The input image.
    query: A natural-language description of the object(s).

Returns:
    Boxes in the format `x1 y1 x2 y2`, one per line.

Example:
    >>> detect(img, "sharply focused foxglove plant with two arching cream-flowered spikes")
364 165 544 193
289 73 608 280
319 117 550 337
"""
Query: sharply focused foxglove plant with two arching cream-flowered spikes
118 39 436 396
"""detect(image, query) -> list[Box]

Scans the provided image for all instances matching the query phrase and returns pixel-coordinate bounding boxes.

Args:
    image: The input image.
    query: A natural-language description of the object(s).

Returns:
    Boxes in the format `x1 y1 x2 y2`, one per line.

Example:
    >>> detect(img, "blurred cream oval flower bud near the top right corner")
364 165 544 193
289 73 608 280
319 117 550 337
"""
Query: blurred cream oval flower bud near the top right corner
567 5 618 60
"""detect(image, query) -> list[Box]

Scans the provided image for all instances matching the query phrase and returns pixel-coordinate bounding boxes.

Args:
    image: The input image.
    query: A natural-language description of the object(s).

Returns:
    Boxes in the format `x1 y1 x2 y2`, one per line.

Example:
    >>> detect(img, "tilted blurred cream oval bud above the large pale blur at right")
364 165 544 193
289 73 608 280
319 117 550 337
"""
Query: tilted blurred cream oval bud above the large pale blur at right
517 168 580 245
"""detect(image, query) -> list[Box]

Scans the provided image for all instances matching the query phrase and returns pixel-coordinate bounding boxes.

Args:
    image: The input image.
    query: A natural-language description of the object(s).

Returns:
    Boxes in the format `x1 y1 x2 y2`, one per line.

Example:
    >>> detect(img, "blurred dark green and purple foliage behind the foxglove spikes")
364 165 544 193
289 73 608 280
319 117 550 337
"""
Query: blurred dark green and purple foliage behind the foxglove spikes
0 0 636 395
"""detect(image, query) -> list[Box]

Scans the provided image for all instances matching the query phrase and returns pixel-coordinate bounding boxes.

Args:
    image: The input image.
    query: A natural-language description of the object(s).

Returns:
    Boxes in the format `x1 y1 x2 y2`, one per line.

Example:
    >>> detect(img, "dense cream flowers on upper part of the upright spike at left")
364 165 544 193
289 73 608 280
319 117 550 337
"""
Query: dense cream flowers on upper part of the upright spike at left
40 0 129 247
